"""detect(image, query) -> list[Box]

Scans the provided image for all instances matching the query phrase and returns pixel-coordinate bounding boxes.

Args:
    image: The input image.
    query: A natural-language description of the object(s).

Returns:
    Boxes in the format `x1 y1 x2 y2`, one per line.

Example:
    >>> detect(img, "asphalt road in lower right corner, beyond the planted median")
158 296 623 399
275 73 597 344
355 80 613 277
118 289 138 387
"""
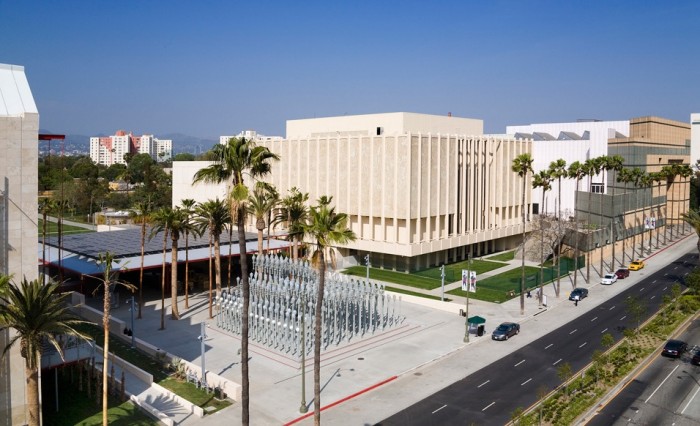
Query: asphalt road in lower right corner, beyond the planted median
588 320 700 426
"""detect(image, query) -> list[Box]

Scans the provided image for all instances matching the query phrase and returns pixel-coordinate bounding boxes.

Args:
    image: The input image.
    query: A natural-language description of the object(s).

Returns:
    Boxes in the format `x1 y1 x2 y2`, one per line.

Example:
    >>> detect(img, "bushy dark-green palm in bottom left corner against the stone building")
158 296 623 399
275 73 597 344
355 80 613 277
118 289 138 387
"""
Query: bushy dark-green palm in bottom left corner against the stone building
0 277 86 426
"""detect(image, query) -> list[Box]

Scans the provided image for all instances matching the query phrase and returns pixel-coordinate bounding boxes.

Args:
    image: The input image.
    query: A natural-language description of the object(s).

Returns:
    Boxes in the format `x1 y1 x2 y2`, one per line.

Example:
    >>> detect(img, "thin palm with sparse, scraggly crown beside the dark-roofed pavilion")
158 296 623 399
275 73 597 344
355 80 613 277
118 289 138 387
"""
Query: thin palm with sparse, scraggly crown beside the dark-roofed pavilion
93 252 135 426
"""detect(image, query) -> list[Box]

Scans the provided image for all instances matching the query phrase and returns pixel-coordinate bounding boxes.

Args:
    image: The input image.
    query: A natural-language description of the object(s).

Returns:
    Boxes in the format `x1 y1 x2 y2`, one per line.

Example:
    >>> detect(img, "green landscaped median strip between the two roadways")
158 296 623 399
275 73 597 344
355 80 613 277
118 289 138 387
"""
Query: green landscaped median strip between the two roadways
511 294 700 426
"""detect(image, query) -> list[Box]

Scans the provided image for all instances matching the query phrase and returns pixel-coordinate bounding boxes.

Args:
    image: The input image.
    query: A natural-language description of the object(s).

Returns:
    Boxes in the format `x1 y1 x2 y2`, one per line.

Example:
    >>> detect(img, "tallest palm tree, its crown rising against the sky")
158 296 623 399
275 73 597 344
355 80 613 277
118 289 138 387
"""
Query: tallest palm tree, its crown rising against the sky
194 138 279 426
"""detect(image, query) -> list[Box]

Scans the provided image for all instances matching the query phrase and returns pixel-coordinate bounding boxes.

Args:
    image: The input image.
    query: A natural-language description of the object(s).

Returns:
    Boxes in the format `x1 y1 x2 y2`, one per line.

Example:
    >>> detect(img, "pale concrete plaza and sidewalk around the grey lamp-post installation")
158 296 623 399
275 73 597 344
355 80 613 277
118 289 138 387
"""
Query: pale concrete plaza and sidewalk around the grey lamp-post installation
100 234 697 425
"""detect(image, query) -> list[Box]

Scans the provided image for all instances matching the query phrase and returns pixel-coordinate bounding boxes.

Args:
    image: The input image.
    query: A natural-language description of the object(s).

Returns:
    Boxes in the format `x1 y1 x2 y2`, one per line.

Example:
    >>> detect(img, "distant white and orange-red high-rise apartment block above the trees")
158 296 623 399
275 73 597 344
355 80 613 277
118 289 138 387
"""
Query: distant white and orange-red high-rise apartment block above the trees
90 130 173 166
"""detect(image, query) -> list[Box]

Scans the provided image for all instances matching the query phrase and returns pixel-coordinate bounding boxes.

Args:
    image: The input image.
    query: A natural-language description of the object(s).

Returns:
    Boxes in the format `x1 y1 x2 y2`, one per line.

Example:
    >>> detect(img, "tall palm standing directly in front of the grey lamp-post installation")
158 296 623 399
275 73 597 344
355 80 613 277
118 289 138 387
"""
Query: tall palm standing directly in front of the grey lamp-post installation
304 197 356 426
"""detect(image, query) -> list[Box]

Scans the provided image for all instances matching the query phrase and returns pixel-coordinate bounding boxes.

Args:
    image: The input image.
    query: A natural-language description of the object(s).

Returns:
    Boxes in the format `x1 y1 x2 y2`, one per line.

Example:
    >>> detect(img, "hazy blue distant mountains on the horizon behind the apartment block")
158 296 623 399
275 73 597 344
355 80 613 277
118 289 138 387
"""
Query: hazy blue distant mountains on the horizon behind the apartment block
39 129 219 155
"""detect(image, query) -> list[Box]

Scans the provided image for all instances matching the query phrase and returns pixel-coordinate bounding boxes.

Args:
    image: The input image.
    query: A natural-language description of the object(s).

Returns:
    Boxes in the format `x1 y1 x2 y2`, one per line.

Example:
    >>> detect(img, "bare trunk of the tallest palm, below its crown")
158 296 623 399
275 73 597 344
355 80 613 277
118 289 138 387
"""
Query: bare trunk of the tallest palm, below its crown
236 208 250 426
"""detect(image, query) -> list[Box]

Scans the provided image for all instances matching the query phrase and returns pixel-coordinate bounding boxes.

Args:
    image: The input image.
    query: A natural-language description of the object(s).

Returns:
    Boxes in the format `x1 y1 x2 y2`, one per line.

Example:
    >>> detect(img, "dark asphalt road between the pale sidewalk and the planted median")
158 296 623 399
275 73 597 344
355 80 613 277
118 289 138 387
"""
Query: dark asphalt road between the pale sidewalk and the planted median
378 253 698 426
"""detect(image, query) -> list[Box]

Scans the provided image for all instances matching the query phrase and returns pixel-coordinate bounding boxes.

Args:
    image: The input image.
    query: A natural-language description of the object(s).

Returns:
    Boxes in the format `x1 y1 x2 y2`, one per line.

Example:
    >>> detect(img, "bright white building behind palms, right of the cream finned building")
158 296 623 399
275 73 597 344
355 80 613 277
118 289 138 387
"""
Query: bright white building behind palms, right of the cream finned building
506 120 630 218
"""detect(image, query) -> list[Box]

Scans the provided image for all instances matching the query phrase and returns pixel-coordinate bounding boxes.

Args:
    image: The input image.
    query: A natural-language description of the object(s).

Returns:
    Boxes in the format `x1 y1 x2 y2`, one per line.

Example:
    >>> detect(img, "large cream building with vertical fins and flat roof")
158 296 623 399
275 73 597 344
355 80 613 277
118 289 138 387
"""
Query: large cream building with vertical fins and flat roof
173 112 531 271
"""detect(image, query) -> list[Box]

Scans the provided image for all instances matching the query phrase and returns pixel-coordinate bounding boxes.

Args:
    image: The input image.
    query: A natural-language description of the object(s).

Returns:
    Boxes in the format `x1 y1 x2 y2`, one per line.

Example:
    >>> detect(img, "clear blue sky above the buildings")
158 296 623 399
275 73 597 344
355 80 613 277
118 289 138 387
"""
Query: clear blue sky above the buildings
0 0 700 137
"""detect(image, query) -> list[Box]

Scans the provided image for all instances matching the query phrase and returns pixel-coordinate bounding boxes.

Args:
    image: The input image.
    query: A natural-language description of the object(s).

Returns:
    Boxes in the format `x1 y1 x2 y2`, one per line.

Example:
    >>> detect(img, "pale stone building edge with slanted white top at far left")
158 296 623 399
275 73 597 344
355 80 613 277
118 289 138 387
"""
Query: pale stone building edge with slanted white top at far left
0 64 39 425
